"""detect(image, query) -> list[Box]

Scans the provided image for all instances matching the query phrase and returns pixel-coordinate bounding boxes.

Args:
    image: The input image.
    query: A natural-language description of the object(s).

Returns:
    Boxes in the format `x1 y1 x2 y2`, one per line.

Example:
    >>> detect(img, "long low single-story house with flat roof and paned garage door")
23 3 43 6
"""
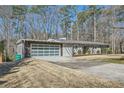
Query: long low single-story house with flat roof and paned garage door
16 39 109 57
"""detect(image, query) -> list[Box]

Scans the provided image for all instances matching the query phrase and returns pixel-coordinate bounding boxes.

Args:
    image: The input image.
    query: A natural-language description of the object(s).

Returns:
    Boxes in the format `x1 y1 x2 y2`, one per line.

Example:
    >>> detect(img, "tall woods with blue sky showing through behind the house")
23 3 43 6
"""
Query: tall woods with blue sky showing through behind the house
0 5 124 60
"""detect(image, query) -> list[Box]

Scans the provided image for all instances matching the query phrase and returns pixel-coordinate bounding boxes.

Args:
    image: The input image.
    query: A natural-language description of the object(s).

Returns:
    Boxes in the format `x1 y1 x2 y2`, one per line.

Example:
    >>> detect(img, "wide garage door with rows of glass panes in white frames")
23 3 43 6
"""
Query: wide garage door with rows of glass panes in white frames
31 44 60 56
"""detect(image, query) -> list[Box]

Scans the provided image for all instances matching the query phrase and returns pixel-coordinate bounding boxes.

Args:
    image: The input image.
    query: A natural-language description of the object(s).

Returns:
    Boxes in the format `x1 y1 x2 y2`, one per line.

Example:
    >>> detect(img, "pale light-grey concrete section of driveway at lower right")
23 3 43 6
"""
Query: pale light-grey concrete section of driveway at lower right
85 63 124 83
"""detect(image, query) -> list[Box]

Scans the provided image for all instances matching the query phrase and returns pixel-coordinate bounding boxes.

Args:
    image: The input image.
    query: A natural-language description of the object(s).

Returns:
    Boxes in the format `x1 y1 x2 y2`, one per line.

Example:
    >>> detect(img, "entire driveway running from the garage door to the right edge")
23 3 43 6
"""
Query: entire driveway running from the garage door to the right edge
36 57 124 83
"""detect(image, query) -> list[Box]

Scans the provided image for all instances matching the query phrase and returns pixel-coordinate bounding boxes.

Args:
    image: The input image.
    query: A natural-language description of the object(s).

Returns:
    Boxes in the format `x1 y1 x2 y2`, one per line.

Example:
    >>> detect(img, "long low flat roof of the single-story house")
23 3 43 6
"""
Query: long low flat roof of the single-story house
16 39 109 46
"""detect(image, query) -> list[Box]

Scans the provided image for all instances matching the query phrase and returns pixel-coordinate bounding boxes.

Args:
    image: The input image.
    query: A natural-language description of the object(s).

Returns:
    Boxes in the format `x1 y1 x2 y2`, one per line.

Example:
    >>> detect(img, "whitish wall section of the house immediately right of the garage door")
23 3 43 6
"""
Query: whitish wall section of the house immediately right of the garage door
62 44 73 56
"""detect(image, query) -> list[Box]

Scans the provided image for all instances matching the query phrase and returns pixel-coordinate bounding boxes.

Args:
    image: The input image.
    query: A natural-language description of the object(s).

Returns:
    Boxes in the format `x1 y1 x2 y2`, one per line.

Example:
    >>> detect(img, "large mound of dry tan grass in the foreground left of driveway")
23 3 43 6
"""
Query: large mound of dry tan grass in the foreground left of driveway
0 60 123 88
